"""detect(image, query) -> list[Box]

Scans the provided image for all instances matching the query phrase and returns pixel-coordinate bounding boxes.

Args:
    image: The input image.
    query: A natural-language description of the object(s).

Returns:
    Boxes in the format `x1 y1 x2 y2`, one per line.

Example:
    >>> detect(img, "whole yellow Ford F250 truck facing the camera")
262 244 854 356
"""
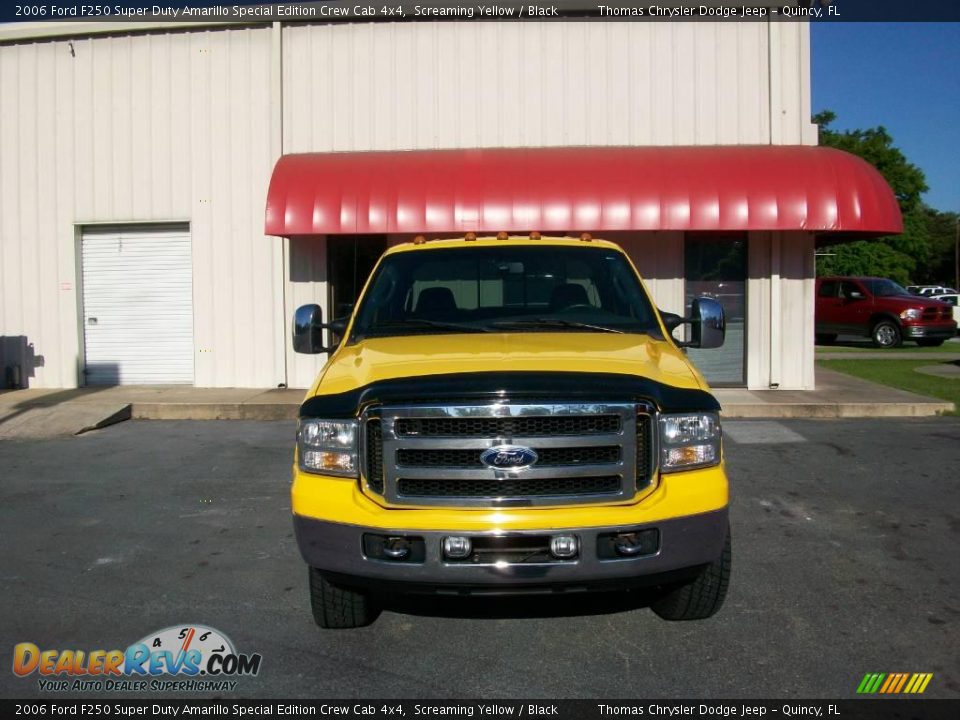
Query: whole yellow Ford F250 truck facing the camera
291 233 731 628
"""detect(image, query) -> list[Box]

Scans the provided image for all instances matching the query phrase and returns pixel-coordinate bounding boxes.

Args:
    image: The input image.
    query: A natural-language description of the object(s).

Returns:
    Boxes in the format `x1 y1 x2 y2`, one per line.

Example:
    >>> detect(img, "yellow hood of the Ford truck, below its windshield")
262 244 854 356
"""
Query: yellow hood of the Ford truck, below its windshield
309 332 706 396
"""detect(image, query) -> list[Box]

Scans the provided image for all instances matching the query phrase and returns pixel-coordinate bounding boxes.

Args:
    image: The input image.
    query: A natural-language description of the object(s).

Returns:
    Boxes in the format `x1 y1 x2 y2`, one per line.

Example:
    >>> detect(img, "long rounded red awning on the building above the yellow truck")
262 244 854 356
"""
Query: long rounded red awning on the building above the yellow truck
266 146 903 236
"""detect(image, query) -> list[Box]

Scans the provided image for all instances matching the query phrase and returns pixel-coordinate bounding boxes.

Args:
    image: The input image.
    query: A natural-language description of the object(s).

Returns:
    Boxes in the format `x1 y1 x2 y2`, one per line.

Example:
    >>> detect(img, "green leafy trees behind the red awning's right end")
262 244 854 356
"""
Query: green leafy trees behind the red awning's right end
813 110 956 284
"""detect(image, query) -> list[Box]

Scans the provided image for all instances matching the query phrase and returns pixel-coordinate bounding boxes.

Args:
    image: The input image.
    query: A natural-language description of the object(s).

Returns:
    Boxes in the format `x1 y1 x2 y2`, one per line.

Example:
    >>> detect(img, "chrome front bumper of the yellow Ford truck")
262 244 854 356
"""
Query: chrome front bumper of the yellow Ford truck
294 507 728 594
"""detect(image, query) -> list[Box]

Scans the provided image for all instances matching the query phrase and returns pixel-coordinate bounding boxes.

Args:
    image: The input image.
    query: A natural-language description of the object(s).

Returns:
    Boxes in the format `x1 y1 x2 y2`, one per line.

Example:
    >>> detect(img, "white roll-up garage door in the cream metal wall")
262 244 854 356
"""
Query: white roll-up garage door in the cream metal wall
81 227 193 385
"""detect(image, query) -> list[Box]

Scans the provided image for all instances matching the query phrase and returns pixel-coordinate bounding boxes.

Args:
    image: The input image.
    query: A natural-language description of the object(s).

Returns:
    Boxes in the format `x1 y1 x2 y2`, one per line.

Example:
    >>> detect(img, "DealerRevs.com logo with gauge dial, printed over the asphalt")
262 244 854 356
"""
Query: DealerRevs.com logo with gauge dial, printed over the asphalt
13 625 262 692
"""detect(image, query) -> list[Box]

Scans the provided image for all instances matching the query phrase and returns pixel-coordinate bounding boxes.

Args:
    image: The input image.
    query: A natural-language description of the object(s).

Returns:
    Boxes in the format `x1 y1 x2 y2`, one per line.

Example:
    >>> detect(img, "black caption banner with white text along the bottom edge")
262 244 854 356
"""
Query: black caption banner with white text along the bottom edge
0 698 960 720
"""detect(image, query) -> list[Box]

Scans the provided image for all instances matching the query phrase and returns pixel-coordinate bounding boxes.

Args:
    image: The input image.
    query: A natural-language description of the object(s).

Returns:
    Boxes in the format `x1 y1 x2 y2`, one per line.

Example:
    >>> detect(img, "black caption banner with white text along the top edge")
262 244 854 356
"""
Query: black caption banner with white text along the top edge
0 0 960 25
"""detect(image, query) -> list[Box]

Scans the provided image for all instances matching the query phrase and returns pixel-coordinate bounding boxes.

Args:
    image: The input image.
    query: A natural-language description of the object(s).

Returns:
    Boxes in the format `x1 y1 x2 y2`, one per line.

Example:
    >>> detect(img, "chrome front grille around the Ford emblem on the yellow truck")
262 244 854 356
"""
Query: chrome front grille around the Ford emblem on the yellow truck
361 403 654 507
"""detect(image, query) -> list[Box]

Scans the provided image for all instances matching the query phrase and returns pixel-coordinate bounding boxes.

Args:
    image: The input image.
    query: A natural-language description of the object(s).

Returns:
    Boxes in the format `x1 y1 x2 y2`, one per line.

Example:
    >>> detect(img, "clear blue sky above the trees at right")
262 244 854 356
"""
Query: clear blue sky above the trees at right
810 22 960 212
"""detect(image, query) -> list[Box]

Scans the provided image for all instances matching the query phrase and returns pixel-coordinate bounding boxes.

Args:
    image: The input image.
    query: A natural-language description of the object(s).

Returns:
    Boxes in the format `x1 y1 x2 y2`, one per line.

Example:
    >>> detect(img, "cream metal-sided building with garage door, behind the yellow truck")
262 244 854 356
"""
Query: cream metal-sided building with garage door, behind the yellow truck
0 21 899 389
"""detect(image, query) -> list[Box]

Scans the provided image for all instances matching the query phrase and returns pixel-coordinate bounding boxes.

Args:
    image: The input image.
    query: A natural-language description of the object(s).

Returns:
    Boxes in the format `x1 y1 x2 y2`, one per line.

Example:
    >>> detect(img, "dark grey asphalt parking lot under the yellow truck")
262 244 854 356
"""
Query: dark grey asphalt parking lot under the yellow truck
0 418 960 698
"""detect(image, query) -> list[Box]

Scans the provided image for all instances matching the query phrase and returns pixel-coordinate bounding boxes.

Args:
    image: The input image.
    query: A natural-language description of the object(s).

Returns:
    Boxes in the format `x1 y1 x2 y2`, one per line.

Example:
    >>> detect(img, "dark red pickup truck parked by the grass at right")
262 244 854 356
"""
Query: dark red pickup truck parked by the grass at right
814 277 957 348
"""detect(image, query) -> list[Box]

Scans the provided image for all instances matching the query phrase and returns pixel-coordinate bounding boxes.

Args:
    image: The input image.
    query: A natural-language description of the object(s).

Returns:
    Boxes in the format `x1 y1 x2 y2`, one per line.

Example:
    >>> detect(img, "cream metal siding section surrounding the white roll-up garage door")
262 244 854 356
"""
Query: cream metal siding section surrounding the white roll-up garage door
0 28 285 387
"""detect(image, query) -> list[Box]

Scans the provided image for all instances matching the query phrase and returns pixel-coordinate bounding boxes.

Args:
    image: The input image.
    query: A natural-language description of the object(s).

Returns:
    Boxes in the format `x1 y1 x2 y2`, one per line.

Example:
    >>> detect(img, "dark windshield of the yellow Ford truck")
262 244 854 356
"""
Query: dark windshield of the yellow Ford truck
350 245 659 342
